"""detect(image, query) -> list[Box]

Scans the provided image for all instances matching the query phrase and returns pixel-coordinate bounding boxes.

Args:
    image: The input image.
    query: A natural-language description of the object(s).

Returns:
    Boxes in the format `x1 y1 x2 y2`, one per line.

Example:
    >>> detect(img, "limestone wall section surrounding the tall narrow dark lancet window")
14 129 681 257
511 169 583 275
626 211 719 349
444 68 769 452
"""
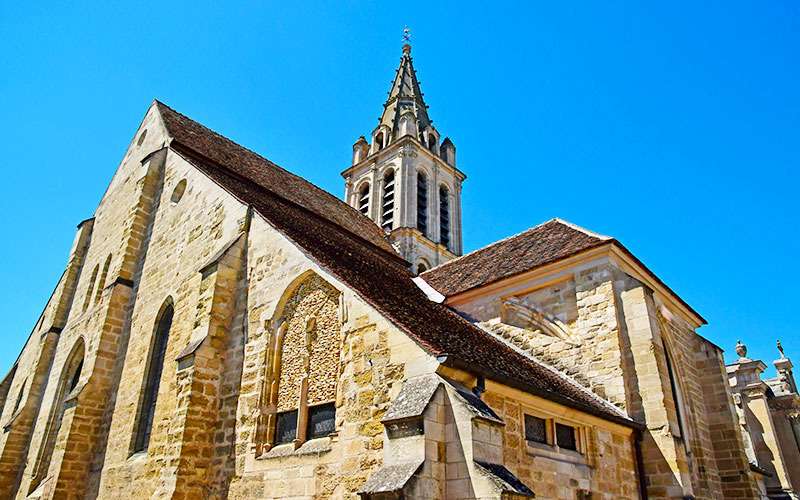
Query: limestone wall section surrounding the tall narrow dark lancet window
91 148 248 497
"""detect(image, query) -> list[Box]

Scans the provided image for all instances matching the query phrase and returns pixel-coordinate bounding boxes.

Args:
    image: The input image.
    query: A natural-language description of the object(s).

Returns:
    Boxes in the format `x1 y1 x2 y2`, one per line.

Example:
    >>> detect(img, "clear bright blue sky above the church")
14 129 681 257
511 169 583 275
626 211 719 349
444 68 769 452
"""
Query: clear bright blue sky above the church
0 1 800 376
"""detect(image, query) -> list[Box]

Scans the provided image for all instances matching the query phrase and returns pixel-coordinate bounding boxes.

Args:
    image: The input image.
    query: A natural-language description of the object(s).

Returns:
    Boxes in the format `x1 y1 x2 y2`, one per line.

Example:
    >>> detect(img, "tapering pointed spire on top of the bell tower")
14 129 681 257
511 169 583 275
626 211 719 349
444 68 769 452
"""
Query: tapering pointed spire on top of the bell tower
380 44 432 133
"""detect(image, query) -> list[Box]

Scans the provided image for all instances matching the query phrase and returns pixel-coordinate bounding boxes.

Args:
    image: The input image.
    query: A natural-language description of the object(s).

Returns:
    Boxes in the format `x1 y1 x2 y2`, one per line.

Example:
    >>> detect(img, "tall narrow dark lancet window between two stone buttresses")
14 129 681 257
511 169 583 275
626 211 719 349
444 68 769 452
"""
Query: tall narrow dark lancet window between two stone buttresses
133 301 175 452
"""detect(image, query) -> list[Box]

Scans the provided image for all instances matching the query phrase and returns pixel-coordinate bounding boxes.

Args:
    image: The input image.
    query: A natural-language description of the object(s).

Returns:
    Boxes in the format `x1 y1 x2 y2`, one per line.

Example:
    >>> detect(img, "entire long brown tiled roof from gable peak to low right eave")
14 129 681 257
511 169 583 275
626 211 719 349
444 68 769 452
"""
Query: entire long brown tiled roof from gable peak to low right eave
156 101 637 426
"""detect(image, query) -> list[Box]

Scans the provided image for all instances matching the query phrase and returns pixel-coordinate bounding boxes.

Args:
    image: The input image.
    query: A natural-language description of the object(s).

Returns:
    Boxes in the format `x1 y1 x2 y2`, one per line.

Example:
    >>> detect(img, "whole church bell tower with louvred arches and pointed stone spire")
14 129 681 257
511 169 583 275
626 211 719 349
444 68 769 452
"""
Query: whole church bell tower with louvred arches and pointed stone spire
342 44 466 273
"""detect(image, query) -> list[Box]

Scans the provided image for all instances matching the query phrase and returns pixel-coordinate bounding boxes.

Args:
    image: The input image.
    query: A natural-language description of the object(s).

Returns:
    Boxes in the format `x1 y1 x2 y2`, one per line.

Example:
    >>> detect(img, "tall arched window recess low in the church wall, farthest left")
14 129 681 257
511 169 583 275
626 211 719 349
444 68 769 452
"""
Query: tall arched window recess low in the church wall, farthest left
30 337 85 491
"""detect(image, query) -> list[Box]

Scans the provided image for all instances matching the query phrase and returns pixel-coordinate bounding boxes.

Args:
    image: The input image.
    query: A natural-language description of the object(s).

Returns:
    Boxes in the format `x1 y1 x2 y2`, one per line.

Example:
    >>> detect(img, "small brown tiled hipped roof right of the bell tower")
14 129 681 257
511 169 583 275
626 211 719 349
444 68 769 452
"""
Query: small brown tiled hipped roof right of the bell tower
422 219 613 297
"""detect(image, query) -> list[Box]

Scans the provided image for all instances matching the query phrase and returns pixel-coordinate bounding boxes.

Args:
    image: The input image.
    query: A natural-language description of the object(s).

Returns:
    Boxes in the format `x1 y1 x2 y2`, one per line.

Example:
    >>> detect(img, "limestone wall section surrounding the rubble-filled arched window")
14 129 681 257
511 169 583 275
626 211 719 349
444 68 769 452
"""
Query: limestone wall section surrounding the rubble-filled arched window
228 217 436 499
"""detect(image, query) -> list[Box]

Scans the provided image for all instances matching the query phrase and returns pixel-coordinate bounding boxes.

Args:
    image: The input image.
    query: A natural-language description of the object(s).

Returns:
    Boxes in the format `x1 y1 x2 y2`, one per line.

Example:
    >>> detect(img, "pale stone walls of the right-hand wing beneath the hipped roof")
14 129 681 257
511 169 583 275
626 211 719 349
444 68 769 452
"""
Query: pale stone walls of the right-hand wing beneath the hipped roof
454 258 755 499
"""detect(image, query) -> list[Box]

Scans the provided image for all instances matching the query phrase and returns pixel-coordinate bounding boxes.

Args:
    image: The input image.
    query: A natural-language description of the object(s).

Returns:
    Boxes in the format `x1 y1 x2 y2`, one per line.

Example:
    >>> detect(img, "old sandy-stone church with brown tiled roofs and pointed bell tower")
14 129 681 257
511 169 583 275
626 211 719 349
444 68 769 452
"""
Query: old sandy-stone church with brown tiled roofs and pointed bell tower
0 45 776 500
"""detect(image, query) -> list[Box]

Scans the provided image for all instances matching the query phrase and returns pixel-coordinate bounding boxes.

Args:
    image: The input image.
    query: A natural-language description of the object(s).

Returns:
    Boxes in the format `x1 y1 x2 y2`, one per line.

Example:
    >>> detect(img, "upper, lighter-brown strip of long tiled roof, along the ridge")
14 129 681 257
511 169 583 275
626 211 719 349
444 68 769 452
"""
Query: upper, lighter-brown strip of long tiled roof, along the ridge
155 101 399 257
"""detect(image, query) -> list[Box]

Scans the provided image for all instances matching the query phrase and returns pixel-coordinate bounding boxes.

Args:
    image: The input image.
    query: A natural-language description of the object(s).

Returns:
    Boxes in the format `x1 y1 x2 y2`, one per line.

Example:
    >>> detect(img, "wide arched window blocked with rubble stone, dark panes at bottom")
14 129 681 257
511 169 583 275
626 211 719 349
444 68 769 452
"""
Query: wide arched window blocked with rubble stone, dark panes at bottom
259 274 341 451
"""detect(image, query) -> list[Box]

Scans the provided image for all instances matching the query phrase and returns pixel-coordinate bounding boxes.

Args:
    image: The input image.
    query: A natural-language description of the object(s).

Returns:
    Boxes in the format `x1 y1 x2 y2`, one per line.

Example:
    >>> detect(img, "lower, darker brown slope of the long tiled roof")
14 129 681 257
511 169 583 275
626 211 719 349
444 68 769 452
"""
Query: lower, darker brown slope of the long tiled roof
156 100 635 425
